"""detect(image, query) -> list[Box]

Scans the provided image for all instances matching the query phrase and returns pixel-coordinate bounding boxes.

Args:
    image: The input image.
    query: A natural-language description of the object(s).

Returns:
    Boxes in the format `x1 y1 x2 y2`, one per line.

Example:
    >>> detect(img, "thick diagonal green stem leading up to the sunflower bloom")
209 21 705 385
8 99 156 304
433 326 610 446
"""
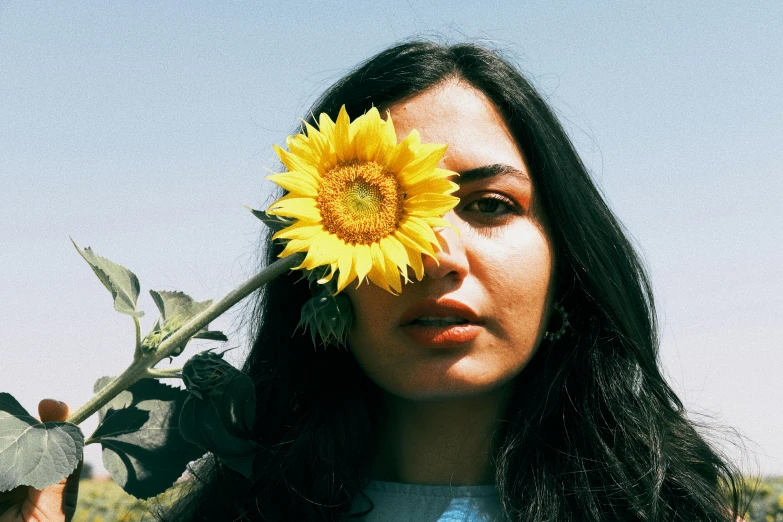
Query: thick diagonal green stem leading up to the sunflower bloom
66 255 302 424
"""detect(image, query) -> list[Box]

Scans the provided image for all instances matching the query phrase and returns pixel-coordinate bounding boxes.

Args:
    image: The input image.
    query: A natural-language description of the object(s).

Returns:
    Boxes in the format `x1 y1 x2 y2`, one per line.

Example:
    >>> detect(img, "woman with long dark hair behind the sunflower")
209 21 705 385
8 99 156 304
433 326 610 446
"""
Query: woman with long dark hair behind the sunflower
4 42 741 521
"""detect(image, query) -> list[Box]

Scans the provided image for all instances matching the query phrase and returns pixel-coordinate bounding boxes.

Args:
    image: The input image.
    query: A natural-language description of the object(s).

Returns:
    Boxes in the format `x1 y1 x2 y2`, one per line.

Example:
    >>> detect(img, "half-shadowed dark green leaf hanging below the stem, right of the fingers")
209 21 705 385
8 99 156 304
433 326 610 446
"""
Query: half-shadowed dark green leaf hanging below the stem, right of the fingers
91 379 204 499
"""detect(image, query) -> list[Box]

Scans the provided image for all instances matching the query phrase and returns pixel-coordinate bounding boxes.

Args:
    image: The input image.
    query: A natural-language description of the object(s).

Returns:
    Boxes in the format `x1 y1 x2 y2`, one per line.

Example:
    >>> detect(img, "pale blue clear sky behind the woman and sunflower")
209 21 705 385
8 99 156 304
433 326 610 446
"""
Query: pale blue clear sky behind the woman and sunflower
0 1 783 474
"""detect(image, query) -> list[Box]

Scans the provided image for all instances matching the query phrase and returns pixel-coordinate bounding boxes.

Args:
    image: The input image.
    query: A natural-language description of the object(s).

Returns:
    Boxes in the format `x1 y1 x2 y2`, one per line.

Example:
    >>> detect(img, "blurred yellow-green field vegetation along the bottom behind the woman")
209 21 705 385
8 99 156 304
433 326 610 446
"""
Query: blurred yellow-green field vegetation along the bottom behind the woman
73 477 783 522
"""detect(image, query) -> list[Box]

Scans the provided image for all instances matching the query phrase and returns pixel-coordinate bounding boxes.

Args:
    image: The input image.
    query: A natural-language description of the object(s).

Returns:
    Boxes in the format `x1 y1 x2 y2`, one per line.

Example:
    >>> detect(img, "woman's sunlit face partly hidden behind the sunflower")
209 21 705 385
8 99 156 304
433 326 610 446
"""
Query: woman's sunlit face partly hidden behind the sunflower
345 82 554 400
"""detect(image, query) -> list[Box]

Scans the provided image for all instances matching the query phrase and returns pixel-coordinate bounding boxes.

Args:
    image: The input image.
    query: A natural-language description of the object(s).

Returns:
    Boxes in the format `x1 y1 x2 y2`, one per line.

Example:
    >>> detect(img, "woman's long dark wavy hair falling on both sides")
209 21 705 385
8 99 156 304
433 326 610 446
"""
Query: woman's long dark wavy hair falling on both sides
163 42 744 522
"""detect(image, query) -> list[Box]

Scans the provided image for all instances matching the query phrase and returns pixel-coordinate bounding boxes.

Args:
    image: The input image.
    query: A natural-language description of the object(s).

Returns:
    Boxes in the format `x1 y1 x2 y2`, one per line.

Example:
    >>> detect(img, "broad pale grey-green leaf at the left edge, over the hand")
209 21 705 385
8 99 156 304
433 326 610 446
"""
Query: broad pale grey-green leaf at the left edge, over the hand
0 393 84 491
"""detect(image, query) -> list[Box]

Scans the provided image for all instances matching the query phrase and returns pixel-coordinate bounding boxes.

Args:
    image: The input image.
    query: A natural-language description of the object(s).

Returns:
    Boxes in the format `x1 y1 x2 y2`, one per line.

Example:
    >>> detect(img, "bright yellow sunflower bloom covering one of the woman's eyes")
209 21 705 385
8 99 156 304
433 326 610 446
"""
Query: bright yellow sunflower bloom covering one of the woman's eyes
267 106 459 294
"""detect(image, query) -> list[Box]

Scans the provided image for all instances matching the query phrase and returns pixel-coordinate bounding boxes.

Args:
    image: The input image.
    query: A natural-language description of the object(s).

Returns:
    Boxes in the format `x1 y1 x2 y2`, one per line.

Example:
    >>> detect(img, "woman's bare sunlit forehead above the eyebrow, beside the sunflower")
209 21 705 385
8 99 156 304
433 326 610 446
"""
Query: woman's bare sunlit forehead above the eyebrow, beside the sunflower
389 81 527 172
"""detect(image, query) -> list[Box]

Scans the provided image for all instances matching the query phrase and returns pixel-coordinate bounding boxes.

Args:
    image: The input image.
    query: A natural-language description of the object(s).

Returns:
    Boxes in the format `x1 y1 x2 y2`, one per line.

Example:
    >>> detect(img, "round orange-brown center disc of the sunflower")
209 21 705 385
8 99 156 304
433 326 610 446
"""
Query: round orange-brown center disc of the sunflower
317 161 405 245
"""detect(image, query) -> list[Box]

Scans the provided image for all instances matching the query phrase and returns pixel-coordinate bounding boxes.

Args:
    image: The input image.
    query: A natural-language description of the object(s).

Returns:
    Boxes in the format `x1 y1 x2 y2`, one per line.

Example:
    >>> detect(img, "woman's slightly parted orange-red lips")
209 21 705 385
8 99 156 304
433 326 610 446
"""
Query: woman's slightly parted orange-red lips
400 299 483 348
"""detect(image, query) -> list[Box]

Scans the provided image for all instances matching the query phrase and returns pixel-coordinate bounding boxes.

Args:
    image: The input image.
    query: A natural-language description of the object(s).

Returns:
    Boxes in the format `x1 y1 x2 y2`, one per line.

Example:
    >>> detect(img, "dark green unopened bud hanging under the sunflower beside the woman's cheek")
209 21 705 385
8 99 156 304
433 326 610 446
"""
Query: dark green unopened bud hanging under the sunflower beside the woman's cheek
297 287 353 346
